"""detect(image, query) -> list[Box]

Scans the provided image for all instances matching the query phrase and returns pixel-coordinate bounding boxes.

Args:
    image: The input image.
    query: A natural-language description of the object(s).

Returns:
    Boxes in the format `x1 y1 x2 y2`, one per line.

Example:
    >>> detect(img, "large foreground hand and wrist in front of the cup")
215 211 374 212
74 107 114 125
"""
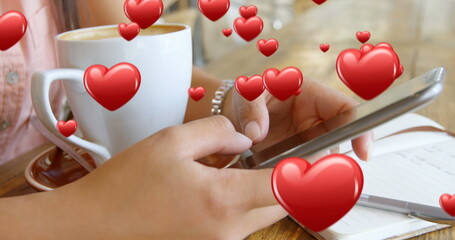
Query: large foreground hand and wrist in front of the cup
6 116 286 240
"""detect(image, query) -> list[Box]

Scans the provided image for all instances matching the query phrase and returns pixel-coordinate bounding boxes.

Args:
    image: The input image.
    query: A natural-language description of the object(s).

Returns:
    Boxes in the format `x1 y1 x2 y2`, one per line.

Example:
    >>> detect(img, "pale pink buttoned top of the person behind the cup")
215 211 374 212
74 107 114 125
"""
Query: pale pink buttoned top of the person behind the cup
0 0 63 164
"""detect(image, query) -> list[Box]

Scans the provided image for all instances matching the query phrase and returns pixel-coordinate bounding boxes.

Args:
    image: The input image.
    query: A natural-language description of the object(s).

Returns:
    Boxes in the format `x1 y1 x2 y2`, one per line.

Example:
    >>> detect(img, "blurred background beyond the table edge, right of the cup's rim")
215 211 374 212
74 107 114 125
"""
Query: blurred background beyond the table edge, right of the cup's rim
163 0 317 66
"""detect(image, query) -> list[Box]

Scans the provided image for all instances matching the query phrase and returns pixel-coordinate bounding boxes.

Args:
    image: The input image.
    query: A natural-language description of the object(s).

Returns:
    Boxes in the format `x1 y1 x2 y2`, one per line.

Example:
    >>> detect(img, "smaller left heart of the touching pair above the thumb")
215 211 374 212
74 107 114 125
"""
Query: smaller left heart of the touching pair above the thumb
235 75 265 101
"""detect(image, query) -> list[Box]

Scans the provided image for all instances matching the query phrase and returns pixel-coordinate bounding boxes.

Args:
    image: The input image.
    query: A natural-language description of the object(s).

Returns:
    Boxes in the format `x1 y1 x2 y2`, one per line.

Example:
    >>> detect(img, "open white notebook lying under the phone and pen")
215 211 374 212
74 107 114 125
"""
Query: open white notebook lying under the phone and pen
304 114 455 240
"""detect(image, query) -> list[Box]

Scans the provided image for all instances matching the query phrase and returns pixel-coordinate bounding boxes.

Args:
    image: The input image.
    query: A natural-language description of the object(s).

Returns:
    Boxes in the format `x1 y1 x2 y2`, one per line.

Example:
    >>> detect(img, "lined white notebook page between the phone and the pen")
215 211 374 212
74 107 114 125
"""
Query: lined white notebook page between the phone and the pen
359 138 455 207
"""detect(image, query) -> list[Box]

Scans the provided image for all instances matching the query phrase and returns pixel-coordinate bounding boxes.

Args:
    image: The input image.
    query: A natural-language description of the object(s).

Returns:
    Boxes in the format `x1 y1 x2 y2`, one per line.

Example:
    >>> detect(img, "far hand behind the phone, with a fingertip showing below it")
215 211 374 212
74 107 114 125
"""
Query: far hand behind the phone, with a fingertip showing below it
223 80 372 160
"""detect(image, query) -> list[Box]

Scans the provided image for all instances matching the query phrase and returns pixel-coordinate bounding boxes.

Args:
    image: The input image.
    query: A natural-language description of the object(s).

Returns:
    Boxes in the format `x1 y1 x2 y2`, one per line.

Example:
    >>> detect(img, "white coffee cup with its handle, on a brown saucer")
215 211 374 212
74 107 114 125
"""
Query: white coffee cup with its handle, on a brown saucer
32 24 192 166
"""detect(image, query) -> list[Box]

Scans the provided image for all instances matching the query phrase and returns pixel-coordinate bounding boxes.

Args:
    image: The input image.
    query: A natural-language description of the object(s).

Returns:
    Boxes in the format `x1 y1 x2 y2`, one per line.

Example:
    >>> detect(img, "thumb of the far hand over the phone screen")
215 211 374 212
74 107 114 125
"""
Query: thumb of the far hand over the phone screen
231 90 269 143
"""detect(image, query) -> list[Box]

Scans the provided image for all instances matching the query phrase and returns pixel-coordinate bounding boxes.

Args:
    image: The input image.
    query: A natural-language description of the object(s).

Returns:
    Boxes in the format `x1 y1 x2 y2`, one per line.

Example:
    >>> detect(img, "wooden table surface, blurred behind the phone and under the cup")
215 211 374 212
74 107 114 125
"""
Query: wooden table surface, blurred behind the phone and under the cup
0 0 455 239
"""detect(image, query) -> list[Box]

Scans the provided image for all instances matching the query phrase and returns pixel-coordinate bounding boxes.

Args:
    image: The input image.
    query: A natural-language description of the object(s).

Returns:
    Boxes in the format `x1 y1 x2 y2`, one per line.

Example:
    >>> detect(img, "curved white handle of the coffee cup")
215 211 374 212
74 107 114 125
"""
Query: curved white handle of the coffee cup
31 69 111 166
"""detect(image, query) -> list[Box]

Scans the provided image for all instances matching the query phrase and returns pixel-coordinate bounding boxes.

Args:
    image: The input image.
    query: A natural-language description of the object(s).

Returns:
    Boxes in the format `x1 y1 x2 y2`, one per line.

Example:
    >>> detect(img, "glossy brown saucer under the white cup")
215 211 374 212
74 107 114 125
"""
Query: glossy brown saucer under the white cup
25 146 95 191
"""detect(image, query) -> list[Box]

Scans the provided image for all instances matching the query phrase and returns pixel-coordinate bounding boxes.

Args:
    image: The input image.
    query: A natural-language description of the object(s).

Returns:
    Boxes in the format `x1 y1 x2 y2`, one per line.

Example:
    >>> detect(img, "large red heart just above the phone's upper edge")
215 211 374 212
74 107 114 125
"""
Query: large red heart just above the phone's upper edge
337 42 402 100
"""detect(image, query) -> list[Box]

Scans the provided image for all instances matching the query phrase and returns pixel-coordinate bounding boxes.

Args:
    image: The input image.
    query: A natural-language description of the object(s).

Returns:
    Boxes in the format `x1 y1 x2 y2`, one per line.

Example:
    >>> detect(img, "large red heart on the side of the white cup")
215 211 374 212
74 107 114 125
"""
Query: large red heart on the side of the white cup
84 62 141 111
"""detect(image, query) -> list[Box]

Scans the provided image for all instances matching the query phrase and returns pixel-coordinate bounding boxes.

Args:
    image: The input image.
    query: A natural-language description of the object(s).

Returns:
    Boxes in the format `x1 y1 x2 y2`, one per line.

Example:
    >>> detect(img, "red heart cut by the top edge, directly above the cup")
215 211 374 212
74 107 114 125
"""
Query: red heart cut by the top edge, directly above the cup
123 0 163 29
